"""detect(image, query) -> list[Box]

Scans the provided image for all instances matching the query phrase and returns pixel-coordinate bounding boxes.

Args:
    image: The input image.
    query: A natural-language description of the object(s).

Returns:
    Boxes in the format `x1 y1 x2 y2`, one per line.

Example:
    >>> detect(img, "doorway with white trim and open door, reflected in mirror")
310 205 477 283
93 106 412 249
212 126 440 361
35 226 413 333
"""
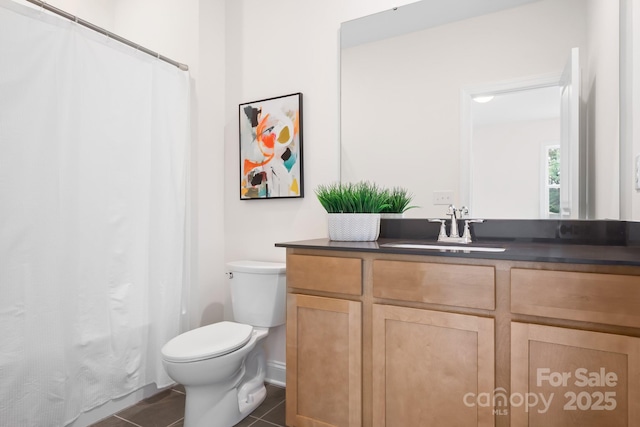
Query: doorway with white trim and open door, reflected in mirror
460 48 585 219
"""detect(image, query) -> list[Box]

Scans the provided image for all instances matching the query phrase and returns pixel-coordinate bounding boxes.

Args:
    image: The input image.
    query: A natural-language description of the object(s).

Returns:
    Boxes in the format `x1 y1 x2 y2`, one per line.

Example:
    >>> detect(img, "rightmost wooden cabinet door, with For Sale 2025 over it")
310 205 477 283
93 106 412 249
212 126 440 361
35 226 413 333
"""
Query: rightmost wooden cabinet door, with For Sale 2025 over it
510 322 640 427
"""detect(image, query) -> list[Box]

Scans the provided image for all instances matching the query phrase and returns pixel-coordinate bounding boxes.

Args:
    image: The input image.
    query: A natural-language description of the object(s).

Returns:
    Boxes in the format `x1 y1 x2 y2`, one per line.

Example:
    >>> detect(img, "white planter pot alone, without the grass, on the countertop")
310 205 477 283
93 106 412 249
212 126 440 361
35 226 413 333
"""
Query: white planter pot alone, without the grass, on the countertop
328 213 380 242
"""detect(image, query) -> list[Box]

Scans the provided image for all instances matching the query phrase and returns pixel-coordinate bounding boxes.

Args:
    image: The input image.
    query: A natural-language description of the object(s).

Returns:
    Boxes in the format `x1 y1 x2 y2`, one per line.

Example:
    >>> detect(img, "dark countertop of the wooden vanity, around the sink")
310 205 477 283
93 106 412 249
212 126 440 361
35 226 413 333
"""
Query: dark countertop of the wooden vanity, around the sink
276 238 640 266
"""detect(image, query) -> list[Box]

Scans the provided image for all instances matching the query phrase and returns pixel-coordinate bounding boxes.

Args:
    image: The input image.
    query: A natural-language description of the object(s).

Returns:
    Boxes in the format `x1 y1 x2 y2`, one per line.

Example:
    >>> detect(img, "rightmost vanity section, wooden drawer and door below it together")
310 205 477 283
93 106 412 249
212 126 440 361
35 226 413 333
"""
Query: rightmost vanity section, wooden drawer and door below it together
511 268 640 427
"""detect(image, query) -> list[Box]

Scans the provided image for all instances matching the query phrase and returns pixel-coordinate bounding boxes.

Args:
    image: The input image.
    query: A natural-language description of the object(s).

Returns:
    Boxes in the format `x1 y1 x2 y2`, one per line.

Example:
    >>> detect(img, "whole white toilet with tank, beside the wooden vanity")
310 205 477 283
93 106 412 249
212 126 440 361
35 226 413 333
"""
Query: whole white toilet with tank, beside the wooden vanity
161 261 286 427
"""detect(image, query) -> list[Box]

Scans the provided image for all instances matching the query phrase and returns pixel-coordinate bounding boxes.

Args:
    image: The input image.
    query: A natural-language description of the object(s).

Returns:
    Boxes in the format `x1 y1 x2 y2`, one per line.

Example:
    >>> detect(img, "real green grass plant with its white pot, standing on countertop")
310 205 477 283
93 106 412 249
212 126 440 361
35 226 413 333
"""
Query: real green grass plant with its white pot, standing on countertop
315 181 388 242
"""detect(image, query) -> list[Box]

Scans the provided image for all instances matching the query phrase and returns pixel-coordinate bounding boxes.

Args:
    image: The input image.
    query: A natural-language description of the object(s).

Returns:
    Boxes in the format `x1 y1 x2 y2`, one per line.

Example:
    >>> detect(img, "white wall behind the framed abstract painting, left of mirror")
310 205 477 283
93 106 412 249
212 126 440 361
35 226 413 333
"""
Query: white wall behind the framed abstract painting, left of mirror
224 0 410 363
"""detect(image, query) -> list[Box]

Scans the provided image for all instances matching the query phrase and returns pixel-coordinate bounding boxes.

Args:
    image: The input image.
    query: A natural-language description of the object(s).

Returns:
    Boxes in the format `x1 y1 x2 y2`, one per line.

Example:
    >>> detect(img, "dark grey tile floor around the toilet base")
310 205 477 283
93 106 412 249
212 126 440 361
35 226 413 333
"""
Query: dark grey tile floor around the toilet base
91 384 285 427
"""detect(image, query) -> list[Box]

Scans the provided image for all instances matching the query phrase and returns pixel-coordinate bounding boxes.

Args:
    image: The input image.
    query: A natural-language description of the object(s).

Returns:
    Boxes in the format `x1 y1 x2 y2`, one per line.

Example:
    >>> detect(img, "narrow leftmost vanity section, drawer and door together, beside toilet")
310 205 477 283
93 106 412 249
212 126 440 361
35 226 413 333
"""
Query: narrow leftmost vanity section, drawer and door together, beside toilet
286 255 362 427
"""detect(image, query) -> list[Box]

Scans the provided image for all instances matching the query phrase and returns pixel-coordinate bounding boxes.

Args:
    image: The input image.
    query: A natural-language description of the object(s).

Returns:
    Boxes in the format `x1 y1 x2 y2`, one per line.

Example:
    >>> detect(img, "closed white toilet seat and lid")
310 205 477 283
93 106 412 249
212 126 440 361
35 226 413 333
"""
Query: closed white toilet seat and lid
162 321 253 363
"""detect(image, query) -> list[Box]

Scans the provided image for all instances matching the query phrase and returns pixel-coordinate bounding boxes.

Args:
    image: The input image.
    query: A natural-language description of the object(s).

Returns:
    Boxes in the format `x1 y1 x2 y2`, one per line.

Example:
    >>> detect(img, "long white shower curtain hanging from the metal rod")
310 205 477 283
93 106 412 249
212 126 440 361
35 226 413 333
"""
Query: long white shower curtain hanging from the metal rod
0 0 189 427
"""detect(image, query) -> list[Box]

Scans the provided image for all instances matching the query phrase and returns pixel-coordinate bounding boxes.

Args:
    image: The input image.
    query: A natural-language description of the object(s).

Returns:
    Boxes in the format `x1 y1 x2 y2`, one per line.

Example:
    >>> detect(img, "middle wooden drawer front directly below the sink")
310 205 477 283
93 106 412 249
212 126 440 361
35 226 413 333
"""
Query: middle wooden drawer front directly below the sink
373 260 496 310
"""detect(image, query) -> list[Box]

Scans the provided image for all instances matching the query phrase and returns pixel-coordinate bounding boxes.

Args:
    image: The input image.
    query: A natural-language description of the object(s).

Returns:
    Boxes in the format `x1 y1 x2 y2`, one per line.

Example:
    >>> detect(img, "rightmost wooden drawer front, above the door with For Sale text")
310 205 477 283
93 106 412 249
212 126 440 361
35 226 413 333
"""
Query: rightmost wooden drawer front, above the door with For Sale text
511 268 640 327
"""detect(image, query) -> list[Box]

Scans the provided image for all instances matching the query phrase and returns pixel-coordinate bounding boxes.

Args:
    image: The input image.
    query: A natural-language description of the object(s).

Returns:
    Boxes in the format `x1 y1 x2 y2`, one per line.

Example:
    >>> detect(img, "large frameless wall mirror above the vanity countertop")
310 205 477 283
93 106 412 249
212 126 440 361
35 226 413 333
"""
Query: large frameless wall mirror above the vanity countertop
341 0 620 219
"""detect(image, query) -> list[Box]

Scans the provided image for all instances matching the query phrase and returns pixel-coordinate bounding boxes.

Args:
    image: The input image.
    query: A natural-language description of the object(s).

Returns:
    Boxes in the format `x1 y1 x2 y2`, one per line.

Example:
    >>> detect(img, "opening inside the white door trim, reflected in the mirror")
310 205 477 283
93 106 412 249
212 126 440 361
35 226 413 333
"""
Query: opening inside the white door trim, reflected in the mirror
470 86 561 218
